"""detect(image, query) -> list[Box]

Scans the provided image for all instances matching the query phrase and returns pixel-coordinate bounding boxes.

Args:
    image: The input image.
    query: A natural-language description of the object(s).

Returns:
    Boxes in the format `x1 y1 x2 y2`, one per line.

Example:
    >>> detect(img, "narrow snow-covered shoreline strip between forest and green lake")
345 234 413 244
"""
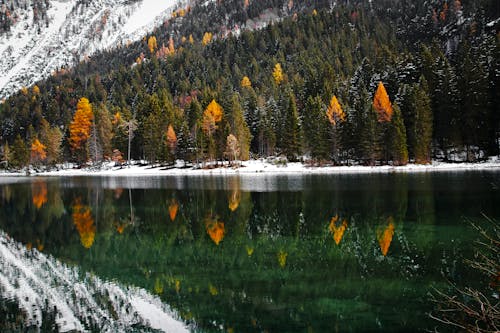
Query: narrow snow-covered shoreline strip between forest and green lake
0 157 500 177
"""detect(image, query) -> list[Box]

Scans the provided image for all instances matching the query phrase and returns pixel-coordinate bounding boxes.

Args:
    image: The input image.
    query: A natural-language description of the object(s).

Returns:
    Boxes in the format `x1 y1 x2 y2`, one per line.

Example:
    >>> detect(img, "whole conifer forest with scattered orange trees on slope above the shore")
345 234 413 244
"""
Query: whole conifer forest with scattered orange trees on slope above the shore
0 0 500 169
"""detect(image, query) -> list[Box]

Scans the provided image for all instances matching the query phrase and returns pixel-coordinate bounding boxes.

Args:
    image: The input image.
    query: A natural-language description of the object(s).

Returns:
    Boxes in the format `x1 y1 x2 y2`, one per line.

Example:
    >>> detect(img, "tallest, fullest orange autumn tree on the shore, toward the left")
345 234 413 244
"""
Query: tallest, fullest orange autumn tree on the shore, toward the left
69 97 94 162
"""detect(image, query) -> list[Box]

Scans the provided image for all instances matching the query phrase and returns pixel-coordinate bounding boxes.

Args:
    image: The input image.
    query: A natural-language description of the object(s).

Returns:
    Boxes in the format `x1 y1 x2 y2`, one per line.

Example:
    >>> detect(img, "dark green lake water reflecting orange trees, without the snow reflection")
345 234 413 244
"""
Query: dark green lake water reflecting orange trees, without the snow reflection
0 171 500 332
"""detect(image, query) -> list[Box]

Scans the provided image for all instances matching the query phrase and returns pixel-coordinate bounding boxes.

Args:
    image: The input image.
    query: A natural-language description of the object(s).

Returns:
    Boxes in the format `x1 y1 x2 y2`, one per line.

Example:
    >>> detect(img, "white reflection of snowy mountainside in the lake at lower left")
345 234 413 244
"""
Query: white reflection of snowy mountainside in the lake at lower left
0 231 188 332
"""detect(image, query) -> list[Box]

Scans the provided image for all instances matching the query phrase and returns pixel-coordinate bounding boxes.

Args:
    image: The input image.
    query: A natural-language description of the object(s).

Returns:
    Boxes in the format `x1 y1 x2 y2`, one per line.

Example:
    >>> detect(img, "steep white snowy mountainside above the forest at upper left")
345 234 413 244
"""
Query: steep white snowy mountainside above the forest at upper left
0 0 176 99
